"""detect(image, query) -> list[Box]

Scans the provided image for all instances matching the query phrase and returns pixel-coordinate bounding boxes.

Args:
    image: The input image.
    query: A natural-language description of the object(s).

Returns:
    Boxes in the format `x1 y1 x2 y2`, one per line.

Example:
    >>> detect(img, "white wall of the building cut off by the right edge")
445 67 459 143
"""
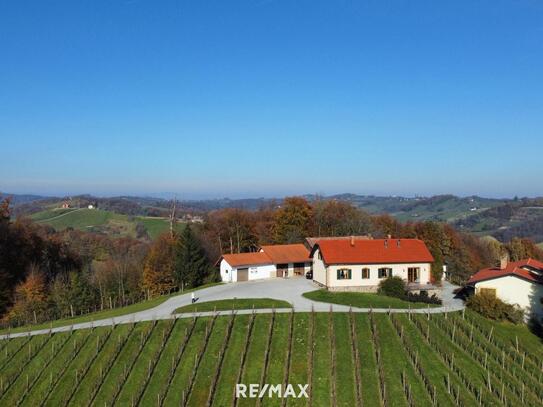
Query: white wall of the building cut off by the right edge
475 276 543 317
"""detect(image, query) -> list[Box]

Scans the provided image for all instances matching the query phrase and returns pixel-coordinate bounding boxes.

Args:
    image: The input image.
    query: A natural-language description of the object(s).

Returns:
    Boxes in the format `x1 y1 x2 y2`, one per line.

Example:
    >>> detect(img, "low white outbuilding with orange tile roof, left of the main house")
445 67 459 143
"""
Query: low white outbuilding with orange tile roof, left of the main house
220 244 311 282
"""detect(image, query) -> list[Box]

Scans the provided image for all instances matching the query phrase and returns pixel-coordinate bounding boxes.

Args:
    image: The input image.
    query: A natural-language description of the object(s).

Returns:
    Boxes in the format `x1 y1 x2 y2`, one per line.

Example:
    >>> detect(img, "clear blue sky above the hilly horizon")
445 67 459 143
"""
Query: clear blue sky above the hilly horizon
0 0 543 198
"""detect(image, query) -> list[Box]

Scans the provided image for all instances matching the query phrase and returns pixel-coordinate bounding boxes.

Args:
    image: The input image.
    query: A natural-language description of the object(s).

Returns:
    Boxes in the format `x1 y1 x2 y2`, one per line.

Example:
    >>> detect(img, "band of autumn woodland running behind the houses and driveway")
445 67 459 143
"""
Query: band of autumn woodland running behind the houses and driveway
0 197 543 325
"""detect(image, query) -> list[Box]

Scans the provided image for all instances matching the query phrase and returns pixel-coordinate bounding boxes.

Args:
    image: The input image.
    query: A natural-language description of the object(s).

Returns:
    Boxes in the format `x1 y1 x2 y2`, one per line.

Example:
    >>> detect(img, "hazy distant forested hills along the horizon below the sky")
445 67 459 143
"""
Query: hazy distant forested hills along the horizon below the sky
5 193 543 242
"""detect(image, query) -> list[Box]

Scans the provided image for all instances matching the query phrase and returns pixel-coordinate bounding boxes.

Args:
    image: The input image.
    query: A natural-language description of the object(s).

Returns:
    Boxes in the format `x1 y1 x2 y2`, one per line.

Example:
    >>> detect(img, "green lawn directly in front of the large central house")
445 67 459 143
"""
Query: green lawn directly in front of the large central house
303 289 439 308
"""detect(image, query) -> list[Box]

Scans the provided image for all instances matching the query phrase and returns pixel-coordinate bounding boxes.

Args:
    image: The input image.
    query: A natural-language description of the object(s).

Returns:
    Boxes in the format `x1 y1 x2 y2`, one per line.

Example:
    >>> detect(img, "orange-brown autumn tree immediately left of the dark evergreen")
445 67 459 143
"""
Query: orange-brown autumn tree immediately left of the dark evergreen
143 233 176 297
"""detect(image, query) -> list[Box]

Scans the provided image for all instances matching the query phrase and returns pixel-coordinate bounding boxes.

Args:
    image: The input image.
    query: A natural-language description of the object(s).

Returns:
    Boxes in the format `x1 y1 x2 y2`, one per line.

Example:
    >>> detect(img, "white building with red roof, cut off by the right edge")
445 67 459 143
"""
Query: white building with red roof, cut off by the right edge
468 259 543 320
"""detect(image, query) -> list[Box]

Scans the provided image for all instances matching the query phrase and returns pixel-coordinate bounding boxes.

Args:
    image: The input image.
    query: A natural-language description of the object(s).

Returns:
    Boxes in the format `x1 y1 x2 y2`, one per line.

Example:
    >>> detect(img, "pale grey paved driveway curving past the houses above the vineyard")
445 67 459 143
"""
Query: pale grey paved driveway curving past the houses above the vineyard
0 278 464 339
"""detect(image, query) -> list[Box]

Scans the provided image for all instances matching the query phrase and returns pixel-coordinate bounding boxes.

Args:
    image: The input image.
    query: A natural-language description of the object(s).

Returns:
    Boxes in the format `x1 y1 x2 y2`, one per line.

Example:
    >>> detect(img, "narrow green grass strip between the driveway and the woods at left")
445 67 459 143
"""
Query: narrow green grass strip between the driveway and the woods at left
0 283 223 334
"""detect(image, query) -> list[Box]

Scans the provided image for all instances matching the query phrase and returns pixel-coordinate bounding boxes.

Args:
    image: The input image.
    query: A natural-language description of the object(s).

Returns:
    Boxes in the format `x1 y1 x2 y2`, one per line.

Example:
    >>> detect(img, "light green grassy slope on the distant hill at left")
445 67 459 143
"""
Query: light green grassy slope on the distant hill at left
31 208 184 239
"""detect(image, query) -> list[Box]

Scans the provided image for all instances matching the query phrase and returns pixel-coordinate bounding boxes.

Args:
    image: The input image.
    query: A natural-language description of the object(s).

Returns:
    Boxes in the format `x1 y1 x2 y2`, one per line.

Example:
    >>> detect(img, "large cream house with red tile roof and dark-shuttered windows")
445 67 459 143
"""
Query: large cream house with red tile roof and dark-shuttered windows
311 237 437 292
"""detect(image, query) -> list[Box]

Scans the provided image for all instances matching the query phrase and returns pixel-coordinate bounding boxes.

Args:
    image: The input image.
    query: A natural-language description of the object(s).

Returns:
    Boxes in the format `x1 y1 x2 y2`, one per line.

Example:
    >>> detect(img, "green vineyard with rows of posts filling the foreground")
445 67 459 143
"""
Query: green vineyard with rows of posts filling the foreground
0 312 543 407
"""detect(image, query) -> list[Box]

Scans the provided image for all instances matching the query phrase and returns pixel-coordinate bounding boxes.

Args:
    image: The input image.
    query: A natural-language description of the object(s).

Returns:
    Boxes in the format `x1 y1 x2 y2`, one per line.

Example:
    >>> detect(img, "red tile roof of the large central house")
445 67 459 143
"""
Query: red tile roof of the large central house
313 239 434 264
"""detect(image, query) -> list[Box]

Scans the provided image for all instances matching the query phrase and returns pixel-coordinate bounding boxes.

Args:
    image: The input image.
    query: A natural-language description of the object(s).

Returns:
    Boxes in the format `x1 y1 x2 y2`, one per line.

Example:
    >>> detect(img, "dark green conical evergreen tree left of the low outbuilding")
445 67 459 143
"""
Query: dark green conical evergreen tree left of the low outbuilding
175 225 213 290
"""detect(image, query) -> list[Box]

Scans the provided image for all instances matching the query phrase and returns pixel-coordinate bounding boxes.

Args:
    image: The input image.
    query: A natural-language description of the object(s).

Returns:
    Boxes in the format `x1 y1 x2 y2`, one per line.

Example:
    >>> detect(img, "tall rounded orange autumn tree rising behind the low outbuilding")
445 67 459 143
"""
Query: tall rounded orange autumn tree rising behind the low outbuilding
273 197 314 243
